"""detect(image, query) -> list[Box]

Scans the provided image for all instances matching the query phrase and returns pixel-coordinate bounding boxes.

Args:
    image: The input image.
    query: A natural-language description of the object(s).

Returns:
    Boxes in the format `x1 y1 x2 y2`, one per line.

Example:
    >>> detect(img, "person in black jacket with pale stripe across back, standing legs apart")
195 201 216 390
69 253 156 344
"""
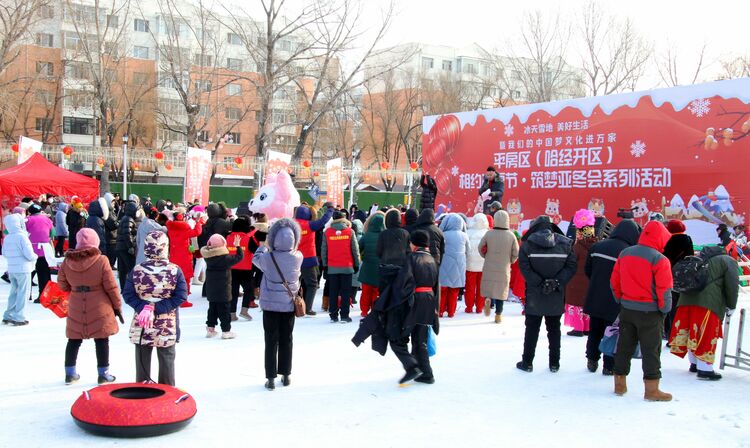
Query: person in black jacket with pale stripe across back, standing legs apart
516 215 576 372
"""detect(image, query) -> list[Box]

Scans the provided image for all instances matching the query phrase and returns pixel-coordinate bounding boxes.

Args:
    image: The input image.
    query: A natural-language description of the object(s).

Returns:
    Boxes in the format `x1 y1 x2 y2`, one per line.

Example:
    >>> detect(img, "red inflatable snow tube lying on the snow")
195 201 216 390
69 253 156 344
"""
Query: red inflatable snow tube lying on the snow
70 383 197 437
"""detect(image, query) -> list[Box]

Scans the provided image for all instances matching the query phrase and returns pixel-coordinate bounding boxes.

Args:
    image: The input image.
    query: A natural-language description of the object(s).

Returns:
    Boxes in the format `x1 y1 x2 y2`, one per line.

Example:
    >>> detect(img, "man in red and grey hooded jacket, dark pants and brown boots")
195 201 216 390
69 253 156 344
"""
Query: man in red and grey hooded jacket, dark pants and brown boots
610 221 672 401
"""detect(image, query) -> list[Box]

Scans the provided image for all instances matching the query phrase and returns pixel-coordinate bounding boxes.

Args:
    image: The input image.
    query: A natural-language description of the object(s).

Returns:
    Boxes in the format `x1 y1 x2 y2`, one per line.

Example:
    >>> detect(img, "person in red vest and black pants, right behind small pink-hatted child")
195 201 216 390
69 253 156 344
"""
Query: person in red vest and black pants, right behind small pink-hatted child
227 216 258 321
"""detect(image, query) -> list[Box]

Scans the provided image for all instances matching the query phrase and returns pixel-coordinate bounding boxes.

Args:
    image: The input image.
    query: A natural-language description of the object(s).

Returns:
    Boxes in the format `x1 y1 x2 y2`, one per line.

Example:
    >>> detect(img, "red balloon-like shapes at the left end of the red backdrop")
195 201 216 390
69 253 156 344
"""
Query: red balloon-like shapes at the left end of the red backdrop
422 115 461 194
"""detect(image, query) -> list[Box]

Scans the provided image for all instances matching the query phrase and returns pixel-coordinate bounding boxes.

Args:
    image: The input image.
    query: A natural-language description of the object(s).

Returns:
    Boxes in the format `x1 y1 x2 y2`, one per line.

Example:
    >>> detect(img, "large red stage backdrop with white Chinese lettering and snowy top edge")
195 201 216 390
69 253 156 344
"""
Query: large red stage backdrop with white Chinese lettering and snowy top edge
422 78 750 240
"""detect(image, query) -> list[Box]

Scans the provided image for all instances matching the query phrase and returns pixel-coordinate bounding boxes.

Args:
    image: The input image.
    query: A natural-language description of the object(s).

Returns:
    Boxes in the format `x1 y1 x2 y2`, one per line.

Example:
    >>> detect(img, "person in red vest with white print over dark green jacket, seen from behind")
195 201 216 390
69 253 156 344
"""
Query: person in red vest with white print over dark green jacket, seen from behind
321 211 360 323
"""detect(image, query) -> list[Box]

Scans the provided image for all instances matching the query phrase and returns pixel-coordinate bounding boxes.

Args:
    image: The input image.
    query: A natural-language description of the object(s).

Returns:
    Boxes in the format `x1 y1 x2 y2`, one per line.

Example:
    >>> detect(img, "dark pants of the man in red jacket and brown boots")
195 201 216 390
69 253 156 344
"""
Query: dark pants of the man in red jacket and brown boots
615 308 664 380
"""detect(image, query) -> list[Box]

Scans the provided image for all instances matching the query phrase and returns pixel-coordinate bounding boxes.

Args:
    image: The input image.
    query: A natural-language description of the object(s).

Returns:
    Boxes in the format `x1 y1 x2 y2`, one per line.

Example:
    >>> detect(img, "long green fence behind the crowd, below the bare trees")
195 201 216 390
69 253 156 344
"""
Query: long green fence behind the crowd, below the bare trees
110 182 419 209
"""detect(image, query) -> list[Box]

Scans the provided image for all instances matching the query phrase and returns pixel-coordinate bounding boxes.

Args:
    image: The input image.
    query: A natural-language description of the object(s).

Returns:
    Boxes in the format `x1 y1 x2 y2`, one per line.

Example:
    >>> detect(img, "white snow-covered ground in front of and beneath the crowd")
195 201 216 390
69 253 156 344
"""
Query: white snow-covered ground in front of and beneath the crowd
0 259 750 447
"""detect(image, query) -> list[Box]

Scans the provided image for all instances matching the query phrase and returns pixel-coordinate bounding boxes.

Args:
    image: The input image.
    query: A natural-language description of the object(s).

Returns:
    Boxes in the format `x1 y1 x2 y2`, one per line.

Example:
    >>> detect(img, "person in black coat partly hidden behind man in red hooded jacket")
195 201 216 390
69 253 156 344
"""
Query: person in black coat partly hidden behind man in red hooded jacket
583 219 641 376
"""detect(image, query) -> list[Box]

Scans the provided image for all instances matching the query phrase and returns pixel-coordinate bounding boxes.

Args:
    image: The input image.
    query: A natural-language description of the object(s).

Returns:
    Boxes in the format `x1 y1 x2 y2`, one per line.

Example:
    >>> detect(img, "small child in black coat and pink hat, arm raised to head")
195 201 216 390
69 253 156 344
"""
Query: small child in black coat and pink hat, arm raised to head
201 233 243 339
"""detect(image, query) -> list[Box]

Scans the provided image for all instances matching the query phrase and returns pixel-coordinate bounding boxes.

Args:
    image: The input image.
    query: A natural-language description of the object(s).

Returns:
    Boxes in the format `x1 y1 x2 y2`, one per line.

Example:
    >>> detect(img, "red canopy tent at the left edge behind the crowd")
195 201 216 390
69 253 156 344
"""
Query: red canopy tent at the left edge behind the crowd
0 153 99 208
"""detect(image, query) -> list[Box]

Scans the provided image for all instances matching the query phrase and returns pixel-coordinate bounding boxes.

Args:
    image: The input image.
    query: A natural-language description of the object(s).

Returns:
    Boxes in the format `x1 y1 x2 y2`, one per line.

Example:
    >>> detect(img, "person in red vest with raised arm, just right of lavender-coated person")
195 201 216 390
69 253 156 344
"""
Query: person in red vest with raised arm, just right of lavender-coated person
294 202 333 316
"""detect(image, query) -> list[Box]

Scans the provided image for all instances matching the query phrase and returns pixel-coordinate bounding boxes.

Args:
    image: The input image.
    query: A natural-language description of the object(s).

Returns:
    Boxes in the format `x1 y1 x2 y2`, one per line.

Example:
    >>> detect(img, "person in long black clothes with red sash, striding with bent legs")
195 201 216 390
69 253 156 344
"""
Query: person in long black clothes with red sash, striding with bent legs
382 230 438 384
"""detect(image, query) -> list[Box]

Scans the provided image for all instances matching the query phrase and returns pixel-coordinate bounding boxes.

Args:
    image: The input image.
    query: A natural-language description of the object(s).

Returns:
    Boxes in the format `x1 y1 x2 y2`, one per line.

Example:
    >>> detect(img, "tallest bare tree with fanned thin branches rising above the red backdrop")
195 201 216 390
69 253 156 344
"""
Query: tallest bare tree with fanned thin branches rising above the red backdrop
579 0 651 96
